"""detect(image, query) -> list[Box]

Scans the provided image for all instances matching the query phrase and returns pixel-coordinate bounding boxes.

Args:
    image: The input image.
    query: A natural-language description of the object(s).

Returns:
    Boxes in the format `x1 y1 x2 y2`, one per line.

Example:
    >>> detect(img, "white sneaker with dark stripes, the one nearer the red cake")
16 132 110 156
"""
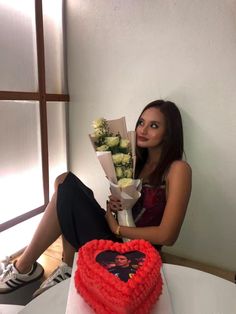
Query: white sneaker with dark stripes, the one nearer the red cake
33 262 72 298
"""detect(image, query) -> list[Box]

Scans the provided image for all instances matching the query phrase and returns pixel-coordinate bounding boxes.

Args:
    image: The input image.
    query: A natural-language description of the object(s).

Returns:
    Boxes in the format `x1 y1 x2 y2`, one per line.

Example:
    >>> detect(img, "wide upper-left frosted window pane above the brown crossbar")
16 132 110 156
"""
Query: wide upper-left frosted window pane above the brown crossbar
0 0 38 92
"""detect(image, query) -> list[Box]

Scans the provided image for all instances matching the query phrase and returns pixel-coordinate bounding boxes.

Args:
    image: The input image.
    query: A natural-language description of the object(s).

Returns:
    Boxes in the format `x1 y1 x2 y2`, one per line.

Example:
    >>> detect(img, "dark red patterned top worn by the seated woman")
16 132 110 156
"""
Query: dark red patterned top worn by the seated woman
132 183 166 227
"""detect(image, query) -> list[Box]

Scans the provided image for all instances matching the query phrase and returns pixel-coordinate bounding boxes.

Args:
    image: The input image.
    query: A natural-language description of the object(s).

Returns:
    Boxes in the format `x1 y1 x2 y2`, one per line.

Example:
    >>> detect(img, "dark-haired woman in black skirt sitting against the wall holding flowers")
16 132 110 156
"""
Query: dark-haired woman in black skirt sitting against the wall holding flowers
0 100 191 296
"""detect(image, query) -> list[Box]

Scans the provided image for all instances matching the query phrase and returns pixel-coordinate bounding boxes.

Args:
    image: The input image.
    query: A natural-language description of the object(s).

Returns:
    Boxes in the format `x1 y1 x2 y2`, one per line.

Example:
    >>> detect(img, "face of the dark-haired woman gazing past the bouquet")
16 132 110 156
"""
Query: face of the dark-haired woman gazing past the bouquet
136 107 166 148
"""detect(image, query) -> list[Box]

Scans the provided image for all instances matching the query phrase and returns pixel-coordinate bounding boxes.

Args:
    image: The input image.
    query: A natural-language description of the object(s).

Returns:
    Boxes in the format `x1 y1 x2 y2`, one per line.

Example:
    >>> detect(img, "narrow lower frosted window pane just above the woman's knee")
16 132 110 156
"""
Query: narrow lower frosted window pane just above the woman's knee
47 102 67 196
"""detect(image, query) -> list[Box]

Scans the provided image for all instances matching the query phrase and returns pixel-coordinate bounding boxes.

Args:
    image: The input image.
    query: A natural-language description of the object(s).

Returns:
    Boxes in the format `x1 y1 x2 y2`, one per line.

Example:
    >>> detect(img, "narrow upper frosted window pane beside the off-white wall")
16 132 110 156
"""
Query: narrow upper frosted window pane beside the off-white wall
43 0 67 94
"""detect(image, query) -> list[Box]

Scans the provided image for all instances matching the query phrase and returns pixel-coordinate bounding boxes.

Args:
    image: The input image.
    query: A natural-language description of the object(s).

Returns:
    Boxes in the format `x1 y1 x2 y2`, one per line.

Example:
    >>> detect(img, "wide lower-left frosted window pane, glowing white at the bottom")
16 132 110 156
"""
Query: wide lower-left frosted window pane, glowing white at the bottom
0 101 44 223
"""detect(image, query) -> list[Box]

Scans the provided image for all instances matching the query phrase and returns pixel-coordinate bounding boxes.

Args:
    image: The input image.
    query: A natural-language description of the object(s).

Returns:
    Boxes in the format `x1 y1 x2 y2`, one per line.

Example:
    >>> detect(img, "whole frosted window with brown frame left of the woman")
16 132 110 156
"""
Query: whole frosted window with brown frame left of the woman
0 0 69 238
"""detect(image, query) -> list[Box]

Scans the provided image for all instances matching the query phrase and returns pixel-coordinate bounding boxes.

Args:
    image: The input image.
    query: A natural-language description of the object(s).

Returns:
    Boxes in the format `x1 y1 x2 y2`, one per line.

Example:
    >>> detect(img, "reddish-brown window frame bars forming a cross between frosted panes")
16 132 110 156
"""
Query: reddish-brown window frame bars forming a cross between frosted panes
0 0 70 232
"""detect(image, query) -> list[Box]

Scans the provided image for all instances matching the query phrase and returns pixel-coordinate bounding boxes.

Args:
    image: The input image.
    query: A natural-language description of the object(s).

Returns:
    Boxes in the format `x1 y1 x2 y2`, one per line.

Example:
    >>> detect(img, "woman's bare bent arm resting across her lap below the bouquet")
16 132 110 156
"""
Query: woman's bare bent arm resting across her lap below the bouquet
106 161 192 245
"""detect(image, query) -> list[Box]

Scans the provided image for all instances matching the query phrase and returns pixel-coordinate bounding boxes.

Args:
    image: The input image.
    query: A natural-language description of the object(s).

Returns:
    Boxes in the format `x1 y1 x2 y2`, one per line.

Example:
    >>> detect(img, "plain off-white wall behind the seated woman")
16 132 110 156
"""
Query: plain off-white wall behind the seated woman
67 0 236 270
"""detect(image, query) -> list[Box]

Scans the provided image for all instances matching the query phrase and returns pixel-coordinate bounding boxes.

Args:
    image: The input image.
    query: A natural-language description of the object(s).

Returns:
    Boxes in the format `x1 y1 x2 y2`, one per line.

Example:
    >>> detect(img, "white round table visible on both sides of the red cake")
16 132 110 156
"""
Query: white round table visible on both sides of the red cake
20 264 236 314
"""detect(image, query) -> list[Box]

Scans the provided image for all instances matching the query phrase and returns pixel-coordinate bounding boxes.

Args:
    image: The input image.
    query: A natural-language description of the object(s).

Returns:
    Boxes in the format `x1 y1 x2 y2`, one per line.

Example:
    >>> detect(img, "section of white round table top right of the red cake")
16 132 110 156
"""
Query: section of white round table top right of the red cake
163 264 236 314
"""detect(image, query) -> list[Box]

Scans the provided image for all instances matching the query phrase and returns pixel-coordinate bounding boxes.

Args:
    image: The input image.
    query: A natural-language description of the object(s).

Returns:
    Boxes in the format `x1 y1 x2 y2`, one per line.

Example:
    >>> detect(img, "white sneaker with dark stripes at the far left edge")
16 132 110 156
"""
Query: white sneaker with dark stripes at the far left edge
0 262 44 294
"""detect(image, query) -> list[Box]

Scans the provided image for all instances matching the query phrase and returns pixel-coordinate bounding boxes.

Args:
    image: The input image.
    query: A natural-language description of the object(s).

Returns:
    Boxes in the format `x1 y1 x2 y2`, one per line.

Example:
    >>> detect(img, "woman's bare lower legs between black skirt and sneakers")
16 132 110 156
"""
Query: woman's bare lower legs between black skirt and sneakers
15 173 75 273
